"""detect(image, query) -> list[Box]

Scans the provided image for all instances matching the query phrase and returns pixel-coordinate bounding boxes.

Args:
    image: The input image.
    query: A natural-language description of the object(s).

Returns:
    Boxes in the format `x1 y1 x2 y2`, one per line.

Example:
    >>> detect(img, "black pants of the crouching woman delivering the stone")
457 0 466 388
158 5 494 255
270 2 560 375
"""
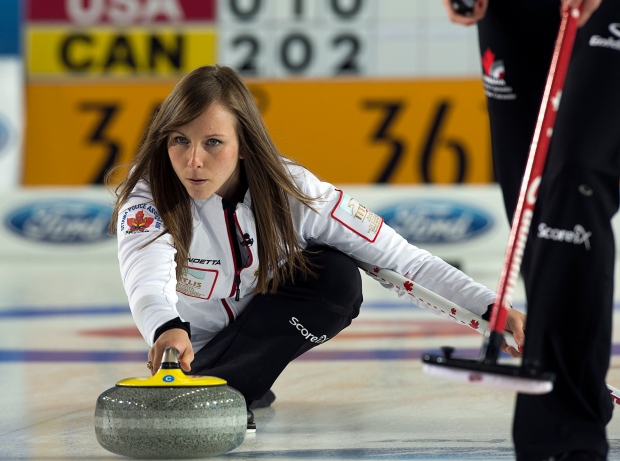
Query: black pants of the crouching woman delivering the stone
191 247 362 404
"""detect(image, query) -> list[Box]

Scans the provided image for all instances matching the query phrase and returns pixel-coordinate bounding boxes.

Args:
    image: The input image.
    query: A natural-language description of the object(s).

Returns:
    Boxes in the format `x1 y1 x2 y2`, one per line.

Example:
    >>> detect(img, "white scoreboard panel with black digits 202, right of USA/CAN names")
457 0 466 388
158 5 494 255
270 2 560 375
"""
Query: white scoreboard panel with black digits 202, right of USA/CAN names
218 0 479 78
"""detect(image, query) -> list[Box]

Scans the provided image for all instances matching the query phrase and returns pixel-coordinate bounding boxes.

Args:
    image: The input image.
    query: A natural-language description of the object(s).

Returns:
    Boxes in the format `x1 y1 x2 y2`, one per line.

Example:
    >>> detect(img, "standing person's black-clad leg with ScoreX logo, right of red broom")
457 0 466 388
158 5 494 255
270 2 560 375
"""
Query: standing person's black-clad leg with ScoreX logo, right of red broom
513 1 620 461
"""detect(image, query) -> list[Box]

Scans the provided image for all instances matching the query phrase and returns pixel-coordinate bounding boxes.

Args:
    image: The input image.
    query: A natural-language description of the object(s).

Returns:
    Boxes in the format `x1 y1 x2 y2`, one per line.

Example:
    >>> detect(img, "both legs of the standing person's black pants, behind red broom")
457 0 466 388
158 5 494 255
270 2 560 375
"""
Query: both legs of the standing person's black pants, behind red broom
479 0 620 460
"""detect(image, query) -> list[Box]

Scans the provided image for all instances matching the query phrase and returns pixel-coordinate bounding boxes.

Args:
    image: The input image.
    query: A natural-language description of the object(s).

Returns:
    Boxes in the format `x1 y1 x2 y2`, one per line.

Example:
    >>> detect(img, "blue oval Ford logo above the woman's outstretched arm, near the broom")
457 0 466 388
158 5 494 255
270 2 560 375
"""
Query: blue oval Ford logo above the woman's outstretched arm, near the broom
377 200 493 245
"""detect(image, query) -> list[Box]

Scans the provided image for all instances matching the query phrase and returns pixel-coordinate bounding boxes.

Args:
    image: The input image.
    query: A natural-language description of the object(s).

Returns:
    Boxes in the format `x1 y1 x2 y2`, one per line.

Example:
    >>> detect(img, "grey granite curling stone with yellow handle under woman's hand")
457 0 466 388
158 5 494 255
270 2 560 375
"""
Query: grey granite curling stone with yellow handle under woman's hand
95 347 247 459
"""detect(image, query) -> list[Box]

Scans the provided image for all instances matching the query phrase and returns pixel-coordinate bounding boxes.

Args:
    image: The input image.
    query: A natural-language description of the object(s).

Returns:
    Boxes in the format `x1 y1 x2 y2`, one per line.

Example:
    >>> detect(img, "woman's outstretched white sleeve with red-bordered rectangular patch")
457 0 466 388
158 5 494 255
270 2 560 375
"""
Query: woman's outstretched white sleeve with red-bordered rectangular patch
293 166 495 315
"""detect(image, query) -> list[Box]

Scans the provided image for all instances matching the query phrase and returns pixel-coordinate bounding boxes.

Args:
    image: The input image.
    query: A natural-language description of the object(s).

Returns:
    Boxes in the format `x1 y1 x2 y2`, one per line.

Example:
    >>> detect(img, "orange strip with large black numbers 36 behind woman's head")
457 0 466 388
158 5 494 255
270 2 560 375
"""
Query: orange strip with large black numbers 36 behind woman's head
24 79 492 185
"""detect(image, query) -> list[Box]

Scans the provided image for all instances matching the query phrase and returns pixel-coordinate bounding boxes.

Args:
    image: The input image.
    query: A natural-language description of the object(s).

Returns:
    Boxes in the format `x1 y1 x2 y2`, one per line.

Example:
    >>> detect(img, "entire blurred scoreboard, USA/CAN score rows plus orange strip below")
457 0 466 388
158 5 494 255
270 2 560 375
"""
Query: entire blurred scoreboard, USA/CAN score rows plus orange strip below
22 0 493 185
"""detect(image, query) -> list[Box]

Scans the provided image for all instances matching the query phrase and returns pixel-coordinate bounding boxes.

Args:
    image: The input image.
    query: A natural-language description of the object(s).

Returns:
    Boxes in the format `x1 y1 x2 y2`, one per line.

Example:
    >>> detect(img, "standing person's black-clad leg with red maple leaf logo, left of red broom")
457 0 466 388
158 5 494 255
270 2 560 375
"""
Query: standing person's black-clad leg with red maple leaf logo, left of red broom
478 0 560 221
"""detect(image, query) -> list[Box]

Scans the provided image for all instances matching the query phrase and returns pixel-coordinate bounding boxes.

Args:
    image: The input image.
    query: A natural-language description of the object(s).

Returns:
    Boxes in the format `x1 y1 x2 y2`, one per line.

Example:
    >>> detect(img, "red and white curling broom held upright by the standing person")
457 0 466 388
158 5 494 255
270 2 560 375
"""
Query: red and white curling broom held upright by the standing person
422 3 580 394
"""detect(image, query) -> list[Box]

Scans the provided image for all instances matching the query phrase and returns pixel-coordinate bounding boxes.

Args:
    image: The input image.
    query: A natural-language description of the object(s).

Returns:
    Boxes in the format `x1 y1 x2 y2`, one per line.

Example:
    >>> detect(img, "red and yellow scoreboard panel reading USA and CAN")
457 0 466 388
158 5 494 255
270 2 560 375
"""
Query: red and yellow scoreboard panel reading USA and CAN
26 0 216 77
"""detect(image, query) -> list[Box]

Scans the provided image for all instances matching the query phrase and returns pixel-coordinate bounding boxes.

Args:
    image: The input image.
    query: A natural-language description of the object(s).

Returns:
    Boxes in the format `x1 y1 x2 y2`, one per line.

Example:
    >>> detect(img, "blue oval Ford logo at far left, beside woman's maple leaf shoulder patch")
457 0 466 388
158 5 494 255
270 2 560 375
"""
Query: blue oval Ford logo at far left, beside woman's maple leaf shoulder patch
5 198 112 244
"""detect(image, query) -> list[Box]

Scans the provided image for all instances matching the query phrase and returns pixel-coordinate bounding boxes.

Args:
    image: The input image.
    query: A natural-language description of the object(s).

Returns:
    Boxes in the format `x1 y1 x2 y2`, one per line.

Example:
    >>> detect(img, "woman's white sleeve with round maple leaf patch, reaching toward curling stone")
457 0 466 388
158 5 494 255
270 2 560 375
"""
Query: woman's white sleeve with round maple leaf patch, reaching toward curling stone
116 184 179 345
